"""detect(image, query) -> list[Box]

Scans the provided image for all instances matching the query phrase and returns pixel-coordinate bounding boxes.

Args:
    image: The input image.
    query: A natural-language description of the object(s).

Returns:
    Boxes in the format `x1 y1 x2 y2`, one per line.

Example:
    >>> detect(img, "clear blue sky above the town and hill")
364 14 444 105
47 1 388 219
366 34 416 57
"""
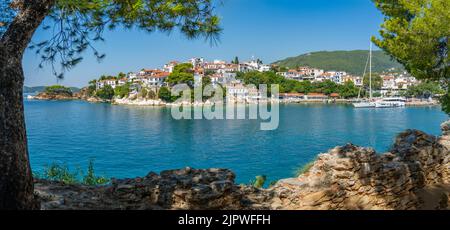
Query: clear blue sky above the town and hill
23 0 383 87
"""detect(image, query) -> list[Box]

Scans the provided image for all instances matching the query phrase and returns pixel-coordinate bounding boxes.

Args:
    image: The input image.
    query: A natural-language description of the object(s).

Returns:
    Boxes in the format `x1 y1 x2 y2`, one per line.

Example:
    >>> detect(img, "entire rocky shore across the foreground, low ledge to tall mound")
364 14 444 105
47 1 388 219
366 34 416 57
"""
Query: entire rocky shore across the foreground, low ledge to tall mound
35 122 450 210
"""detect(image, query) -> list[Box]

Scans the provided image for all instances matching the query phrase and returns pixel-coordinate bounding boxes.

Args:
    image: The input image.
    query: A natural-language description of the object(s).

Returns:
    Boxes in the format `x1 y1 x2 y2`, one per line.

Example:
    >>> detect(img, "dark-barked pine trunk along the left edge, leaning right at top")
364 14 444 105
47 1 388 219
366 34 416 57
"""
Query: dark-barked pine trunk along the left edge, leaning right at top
0 0 55 209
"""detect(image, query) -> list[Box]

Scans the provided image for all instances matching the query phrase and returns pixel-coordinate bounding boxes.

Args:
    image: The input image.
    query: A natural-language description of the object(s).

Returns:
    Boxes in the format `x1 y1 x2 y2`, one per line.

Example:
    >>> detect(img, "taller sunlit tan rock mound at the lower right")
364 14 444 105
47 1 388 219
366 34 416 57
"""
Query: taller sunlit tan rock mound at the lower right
271 125 450 210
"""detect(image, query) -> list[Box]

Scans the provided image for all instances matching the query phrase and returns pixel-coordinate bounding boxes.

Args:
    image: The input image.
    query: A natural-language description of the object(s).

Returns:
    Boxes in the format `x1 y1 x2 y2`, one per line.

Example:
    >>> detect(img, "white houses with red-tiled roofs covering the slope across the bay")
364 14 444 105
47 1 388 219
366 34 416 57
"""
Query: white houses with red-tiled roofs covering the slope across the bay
89 58 428 102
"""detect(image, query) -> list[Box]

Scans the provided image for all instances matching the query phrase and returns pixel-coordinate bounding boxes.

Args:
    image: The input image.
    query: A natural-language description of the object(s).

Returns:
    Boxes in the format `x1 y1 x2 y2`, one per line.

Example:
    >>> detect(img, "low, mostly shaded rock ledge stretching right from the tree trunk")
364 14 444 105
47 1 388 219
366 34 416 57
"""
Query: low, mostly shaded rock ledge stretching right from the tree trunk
35 168 243 210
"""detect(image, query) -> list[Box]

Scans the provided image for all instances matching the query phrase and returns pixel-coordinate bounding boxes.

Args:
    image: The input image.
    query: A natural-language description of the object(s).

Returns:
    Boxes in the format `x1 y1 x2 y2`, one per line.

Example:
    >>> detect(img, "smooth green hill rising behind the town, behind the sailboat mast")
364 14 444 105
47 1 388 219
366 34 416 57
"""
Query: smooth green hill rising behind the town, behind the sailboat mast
273 50 403 75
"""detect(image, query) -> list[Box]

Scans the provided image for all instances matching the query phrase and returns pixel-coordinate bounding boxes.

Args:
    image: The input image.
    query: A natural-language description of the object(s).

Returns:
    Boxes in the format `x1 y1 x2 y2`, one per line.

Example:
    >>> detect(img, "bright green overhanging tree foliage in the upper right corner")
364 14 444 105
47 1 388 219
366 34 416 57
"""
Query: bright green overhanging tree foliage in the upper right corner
372 0 450 114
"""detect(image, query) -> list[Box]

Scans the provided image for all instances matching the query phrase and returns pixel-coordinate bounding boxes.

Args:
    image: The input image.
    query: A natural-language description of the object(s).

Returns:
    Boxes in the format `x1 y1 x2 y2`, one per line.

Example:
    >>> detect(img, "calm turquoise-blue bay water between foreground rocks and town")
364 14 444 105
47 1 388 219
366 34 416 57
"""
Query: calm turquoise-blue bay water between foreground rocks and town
25 101 448 183
